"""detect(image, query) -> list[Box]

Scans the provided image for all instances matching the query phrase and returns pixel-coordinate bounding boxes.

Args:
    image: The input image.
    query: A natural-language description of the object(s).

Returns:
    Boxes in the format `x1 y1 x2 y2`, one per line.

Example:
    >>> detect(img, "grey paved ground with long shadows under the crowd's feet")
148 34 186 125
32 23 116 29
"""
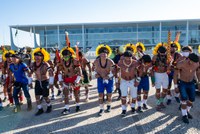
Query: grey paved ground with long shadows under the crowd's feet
0 80 200 134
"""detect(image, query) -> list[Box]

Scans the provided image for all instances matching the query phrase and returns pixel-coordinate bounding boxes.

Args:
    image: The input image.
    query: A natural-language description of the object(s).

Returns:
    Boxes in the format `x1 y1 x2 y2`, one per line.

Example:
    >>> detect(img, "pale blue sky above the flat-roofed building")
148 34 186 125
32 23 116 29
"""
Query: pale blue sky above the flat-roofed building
0 0 200 45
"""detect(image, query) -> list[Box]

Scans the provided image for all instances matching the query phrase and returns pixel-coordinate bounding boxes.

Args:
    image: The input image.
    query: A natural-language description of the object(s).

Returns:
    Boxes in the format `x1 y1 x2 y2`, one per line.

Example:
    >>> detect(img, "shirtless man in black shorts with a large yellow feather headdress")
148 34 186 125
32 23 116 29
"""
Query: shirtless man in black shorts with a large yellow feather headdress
29 48 54 116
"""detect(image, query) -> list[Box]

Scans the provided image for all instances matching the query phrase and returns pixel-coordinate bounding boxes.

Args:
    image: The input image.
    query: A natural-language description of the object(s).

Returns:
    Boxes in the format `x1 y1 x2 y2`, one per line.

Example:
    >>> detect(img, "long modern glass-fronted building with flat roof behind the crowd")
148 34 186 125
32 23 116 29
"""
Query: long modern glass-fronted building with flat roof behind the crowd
10 19 200 52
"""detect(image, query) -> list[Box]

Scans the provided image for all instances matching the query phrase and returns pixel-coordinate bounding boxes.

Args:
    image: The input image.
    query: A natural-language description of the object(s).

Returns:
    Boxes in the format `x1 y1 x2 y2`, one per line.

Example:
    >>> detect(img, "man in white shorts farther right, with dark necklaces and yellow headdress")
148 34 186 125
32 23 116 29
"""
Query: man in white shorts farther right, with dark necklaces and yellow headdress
152 43 170 111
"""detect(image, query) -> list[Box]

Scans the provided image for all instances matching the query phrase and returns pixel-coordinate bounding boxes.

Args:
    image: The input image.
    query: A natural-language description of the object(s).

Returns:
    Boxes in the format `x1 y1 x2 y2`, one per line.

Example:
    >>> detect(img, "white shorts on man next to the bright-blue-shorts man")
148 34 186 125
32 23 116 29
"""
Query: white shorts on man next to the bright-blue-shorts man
120 79 137 98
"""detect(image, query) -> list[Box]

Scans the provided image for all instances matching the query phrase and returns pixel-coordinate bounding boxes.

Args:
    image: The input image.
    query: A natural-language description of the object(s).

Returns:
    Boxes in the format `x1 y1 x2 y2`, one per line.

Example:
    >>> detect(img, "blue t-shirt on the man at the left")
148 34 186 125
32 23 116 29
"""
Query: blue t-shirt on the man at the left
10 63 28 84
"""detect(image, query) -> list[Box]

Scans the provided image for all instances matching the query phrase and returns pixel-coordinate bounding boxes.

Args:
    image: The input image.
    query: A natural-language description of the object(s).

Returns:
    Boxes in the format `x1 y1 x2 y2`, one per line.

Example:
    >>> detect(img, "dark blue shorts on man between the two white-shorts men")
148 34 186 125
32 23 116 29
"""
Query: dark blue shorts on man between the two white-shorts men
138 76 149 91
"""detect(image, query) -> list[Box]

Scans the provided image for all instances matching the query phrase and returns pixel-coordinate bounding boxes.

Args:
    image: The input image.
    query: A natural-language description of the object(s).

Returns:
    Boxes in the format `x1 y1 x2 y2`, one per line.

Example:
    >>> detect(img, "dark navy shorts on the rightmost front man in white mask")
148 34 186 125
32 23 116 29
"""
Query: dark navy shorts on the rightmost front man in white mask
179 80 196 102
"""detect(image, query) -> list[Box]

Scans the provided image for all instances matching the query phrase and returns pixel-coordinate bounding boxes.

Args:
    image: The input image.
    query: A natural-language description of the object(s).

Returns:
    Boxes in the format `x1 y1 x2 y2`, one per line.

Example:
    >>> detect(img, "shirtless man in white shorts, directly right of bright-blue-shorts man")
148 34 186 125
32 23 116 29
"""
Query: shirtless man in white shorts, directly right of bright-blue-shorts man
118 44 141 116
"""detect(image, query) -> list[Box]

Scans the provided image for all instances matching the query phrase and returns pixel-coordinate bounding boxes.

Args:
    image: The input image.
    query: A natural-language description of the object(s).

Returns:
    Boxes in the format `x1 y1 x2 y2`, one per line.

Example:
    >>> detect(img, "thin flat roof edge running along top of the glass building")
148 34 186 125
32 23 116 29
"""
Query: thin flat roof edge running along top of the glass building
9 19 200 28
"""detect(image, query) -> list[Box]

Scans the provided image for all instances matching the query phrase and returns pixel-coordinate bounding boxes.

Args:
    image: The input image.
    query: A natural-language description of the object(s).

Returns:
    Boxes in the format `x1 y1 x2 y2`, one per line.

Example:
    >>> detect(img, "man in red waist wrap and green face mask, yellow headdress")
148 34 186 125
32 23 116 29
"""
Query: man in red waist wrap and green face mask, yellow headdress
58 46 82 115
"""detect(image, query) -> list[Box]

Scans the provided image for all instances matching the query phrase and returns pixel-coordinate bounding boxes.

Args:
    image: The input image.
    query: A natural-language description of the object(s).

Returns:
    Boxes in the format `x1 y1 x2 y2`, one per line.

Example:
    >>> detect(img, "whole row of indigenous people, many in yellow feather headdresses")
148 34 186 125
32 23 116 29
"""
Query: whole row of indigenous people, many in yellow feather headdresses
0 41 200 123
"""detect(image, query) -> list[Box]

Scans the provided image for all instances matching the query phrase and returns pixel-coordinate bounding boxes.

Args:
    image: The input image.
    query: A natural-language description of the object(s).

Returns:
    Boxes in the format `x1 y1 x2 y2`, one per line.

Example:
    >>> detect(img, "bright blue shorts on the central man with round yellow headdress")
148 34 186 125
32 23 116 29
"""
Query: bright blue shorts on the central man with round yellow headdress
97 78 114 93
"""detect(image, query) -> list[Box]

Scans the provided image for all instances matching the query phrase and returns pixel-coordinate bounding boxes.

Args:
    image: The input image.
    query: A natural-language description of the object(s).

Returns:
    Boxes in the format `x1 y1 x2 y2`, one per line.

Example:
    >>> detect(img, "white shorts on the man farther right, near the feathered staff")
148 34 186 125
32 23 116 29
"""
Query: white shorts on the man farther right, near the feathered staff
154 72 169 89
